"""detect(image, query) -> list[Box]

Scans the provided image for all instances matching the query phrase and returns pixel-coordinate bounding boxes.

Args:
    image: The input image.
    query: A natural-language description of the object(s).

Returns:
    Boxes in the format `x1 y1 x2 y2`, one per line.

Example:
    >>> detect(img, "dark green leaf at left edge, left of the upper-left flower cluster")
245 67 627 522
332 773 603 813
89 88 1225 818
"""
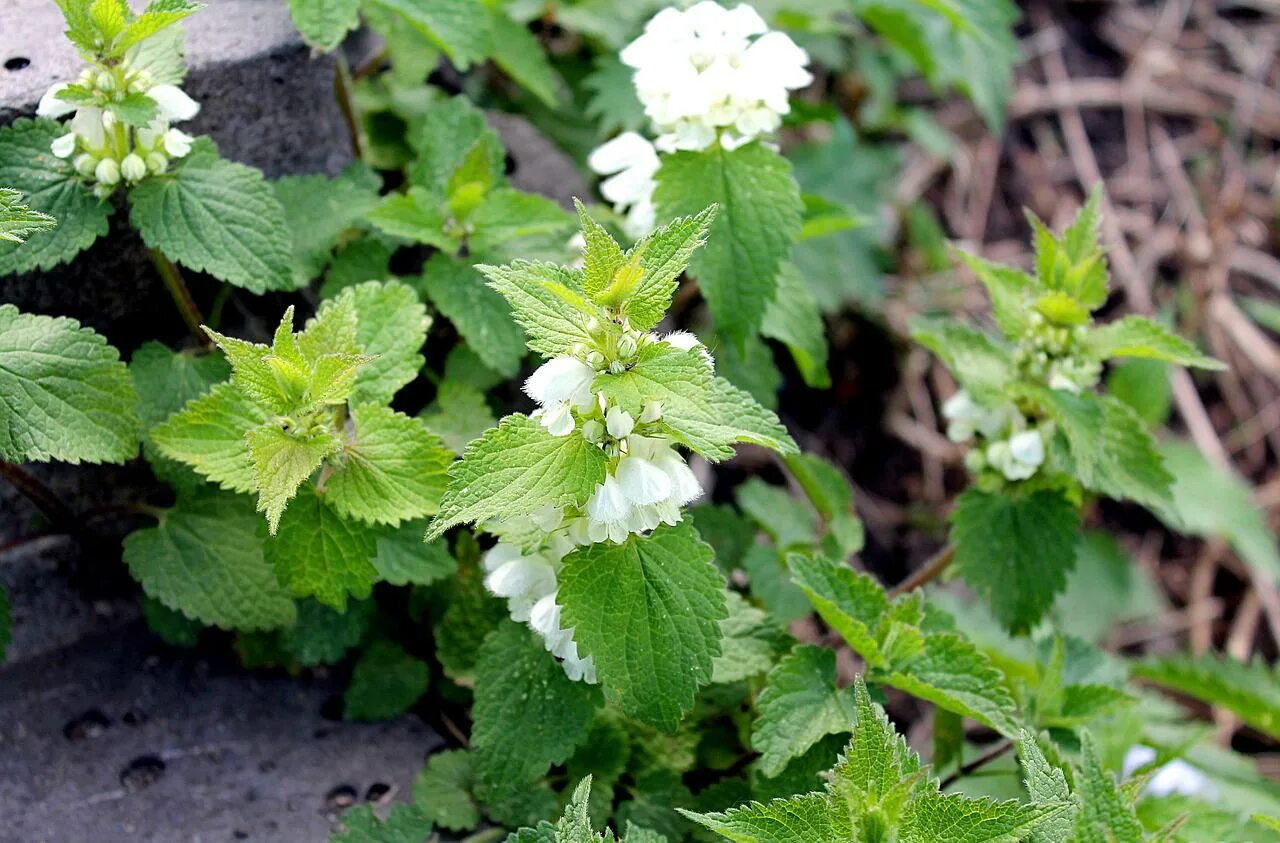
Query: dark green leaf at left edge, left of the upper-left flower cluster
0 118 111 275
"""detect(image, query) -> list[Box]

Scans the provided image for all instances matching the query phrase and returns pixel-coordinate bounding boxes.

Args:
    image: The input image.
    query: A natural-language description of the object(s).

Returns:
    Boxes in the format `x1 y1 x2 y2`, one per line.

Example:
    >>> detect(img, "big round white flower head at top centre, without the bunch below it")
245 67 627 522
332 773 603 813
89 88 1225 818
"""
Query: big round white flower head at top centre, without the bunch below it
620 0 813 151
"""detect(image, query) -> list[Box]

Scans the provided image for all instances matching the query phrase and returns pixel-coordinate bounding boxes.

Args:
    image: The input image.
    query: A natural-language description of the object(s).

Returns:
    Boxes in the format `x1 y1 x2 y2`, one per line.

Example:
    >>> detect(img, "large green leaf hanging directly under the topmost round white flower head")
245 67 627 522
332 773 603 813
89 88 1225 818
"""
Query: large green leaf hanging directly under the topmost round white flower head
653 142 804 345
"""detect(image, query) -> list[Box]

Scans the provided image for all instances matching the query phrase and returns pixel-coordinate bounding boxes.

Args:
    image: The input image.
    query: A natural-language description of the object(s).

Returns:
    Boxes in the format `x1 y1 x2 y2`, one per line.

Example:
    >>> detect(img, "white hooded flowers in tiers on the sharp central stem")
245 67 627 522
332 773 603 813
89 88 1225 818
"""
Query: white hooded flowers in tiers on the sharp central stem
484 331 712 683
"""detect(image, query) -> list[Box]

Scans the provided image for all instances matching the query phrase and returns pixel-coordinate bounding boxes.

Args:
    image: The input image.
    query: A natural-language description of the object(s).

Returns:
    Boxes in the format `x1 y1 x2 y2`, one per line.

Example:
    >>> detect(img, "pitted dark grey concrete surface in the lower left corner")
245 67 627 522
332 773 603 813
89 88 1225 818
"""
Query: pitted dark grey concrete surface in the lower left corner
0 623 440 843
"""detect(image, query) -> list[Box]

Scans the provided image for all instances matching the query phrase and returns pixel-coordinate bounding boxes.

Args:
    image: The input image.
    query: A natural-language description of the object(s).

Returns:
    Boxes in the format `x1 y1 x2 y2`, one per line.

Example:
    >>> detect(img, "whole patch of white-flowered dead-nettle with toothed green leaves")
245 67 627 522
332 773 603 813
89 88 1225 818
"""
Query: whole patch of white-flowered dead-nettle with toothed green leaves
0 0 1280 843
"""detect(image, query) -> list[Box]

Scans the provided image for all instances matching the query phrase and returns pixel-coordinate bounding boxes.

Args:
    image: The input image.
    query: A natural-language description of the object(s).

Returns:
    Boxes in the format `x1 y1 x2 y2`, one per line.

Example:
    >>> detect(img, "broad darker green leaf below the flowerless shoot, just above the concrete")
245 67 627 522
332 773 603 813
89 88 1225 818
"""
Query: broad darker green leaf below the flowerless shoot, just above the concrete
124 491 297 629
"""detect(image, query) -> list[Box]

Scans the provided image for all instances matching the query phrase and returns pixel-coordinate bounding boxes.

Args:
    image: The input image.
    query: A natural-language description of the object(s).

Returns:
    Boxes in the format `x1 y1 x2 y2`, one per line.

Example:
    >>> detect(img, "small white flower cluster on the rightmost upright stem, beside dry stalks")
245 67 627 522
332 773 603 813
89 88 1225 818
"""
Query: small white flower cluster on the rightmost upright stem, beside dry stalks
942 389 1044 480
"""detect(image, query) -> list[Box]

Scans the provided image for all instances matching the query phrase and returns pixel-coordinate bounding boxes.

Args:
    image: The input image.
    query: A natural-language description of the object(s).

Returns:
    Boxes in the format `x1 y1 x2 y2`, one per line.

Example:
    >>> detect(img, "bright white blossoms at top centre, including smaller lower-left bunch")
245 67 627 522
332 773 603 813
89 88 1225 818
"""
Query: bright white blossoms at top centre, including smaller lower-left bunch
588 0 813 238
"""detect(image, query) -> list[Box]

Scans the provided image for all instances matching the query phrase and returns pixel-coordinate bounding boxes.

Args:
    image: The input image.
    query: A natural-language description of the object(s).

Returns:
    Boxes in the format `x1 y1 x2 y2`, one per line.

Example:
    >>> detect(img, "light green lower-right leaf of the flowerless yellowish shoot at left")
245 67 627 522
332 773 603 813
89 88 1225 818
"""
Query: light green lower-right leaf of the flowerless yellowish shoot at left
324 404 453 526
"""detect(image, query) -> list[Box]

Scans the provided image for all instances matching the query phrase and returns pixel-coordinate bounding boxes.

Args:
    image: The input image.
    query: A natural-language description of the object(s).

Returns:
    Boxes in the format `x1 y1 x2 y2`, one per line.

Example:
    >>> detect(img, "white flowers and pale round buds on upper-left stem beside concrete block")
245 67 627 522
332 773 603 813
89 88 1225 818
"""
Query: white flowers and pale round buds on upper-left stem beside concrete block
36 59 200 197
